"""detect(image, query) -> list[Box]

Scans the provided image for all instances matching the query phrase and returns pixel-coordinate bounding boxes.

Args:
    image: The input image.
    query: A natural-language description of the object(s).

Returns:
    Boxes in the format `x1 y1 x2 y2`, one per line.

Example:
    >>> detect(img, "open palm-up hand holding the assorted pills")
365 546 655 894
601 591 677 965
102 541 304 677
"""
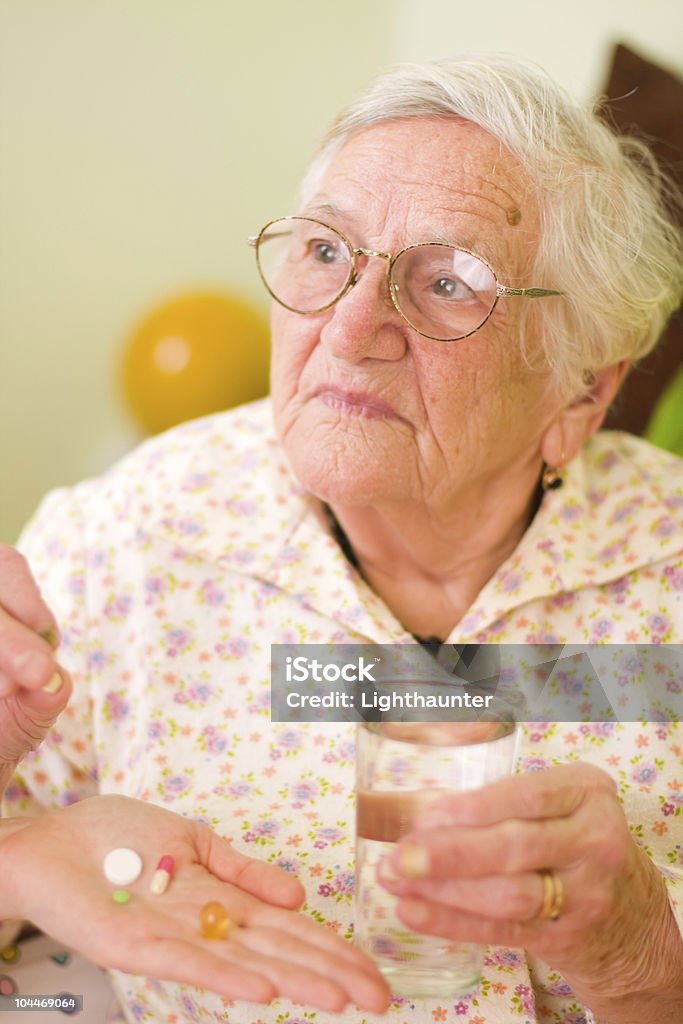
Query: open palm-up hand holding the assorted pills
0 796 389 1012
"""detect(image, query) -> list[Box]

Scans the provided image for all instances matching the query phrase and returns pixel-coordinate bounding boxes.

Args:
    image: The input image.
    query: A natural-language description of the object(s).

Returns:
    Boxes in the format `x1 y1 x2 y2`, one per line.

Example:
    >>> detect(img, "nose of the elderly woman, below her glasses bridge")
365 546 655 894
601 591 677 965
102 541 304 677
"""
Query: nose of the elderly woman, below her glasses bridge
321 259 408 362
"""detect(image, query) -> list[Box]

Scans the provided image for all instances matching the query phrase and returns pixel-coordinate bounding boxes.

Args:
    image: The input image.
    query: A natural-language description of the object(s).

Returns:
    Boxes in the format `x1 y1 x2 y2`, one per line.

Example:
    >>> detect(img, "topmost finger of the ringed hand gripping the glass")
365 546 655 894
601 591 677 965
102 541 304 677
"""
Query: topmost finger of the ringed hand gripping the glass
416 764 614 828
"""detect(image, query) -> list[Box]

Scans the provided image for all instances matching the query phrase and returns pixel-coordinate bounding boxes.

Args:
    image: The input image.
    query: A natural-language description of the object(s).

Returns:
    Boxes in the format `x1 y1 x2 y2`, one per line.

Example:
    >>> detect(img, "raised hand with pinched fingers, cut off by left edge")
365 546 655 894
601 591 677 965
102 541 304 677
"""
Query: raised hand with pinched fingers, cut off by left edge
0 545 72 778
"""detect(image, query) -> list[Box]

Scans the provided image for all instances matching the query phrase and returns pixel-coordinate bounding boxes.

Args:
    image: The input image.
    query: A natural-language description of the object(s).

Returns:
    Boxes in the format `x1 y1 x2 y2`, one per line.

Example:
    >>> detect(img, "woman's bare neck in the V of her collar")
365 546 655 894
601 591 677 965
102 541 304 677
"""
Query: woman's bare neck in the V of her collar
331 481 541 640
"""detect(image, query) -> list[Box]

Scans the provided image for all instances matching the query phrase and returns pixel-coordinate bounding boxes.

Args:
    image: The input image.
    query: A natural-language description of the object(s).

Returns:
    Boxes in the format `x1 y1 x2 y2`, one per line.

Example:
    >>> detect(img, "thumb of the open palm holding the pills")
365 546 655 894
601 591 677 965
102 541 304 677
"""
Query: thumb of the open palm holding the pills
200 826 306 910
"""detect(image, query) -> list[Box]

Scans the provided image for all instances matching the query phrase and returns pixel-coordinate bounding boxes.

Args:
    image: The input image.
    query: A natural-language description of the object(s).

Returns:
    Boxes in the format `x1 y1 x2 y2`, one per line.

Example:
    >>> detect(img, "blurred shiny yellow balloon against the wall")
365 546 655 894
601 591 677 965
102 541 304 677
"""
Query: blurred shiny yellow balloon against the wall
122 292 269 433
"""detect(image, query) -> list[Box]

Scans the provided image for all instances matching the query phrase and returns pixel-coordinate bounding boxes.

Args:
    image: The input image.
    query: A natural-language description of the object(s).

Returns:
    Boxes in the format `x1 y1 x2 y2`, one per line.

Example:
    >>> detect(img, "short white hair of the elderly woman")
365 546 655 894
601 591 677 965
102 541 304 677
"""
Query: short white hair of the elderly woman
301 54 683 395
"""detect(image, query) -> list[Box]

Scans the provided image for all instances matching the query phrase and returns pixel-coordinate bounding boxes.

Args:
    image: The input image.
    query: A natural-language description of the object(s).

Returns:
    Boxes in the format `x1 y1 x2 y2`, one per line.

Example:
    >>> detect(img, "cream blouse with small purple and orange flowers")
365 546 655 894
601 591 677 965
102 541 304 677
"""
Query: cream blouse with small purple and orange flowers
7 400 683 1024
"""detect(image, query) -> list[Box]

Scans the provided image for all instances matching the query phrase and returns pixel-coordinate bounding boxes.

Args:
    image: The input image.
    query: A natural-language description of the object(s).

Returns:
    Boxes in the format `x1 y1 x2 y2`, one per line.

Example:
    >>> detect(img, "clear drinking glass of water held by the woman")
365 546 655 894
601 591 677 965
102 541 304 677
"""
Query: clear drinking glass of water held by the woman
354 721 516 998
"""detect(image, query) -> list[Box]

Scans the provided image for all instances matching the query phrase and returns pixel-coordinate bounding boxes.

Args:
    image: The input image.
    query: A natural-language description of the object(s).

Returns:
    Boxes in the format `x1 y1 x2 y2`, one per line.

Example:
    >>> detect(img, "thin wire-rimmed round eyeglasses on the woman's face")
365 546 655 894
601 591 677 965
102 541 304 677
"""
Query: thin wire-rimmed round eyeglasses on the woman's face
249 217 564 341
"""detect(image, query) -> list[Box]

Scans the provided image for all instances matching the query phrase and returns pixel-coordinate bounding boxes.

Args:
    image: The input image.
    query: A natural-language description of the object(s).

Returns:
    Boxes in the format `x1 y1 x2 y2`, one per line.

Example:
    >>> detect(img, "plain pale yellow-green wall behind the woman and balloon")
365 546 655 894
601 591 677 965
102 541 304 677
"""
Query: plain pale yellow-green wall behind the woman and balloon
0 0 683 541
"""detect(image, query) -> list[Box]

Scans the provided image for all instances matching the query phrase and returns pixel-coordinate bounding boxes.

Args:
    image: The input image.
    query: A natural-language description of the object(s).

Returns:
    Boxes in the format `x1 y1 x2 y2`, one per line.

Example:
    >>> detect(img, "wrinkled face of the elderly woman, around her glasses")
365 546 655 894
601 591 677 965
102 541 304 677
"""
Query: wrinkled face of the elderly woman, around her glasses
271 118 557 511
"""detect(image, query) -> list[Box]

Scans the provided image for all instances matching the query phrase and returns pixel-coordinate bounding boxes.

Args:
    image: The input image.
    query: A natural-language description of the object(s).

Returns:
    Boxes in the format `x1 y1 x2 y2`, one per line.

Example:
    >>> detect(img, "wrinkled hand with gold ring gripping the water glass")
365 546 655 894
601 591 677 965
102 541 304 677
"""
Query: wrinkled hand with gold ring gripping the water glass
380 764 683 1020
